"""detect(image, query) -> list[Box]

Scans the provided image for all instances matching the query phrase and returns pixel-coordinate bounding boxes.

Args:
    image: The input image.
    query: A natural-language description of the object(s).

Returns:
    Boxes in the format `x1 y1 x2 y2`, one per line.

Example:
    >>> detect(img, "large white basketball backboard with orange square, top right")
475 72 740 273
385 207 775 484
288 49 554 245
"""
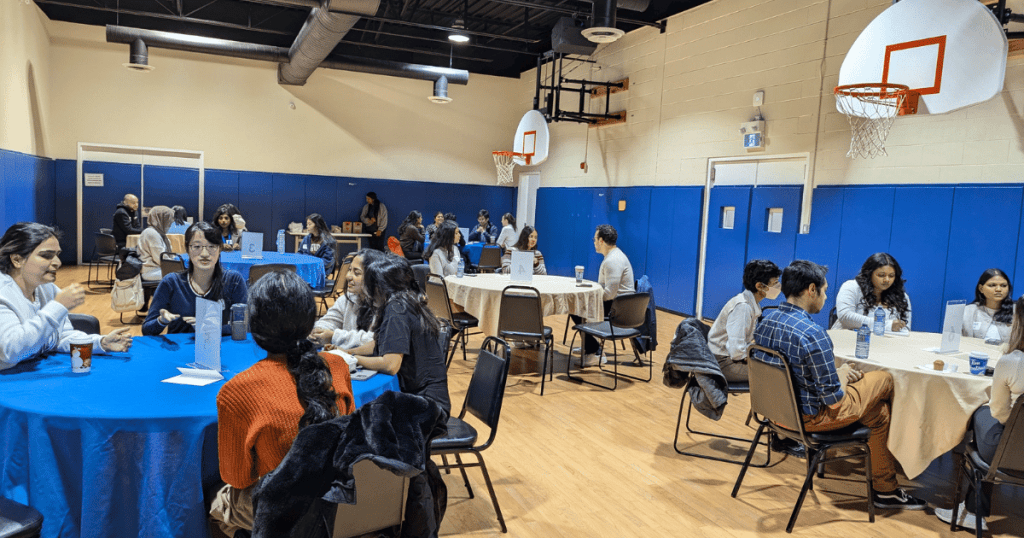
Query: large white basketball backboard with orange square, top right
839 0 1008 114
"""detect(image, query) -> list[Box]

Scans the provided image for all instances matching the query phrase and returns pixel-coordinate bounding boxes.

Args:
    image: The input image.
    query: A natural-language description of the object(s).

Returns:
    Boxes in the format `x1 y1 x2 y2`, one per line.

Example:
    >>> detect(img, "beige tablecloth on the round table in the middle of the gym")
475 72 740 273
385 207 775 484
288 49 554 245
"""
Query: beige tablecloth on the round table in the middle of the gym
444 275 604 336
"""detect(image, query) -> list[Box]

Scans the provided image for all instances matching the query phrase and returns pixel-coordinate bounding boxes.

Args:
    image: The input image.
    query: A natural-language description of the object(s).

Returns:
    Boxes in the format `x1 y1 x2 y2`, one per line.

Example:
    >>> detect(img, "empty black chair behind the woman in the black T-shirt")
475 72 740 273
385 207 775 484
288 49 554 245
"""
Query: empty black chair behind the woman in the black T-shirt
430 336 509 533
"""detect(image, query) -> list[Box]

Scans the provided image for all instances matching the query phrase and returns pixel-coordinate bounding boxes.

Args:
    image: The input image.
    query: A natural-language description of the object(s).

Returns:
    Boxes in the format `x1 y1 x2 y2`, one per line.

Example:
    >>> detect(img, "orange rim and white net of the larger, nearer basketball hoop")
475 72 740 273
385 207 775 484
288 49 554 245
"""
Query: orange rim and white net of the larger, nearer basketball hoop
835 82 919 159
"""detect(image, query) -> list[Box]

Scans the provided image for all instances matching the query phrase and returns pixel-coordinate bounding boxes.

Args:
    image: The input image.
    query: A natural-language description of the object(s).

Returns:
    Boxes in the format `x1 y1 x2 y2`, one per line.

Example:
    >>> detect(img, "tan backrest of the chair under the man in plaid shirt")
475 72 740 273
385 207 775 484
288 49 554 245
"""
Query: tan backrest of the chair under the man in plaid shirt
746 345 806 443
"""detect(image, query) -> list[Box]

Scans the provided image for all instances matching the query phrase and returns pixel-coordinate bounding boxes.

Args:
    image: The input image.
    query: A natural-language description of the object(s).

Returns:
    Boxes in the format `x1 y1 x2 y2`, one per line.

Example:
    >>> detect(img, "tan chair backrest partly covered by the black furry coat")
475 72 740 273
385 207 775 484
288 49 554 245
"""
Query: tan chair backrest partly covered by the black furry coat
332 459 409 538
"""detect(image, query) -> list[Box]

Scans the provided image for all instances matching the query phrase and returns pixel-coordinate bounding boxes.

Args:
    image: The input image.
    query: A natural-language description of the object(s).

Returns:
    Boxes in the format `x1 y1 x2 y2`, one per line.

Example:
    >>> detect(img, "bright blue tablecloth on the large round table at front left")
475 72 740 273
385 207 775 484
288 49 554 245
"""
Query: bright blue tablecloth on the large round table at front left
0 334 398 538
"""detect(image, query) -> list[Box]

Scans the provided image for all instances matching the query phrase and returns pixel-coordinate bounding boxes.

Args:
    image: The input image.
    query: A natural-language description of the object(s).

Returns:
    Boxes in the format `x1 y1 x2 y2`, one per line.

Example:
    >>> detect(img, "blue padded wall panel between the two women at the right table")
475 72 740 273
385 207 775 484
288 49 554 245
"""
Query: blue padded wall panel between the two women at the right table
888 187 954 332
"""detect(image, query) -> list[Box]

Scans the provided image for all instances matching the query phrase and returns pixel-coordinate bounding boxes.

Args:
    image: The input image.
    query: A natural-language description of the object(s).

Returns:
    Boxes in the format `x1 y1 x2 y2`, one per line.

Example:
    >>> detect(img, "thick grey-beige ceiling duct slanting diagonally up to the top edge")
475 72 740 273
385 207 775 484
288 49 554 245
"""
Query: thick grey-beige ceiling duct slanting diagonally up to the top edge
278 0 380 86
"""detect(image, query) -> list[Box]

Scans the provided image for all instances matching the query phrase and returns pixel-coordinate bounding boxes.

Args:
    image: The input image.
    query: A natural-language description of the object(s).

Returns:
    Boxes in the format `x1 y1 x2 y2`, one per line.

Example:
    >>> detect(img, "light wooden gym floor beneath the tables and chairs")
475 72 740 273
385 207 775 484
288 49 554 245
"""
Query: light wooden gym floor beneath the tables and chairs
57 266 1024 538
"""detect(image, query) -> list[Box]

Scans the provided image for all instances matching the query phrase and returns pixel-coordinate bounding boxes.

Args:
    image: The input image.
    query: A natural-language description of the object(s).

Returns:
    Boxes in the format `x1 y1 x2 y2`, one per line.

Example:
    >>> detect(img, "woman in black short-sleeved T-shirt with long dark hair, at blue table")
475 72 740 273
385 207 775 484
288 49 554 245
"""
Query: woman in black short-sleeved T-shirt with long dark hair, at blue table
355 256 452 418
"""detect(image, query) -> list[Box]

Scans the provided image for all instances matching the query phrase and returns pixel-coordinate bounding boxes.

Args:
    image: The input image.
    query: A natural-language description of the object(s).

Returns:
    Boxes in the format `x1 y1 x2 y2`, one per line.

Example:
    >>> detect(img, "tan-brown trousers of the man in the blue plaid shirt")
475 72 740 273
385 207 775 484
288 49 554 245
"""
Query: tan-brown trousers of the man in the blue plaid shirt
804 372 898 493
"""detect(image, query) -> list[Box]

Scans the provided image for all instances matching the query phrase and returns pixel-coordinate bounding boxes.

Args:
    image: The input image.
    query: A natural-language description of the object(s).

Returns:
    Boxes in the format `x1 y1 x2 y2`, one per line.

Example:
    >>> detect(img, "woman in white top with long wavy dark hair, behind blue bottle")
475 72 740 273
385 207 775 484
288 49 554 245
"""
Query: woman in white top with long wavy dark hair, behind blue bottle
831 252 910 332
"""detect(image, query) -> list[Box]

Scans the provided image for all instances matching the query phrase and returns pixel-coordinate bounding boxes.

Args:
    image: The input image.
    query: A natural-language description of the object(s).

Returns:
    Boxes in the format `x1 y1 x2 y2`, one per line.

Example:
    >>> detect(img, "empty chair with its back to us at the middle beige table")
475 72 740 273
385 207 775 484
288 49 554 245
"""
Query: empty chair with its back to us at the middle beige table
498 286 555 396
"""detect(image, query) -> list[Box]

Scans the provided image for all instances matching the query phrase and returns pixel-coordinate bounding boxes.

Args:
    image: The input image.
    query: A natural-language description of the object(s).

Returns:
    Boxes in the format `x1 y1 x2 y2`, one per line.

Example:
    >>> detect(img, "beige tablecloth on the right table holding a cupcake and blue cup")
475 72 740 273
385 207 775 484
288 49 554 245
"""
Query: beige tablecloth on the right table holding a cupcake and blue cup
828 329 1002 479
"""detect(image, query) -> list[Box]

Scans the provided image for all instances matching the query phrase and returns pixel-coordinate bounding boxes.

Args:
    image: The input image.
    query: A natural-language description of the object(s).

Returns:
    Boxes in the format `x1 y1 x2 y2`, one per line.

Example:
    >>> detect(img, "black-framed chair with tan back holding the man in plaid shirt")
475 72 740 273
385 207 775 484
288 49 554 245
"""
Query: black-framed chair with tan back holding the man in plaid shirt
732 345 874 533
